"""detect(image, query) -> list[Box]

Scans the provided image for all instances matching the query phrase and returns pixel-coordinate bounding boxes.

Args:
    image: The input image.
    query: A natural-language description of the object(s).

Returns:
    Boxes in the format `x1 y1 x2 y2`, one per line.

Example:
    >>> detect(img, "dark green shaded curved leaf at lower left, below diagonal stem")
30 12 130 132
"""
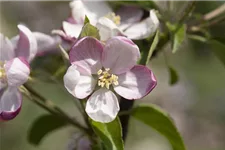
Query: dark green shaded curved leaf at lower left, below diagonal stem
28 115 68 145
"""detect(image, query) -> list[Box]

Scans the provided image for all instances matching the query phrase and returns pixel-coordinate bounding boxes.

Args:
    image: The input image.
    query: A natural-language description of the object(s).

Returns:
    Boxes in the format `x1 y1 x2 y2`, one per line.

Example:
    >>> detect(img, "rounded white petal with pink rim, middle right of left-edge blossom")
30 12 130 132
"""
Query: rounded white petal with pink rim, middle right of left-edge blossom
4 58 30 87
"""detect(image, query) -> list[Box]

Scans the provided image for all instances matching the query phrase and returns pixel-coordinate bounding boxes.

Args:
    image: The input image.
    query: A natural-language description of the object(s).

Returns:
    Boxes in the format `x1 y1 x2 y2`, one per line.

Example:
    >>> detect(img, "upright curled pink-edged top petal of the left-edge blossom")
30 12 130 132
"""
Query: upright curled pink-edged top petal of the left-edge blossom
16 24 37 62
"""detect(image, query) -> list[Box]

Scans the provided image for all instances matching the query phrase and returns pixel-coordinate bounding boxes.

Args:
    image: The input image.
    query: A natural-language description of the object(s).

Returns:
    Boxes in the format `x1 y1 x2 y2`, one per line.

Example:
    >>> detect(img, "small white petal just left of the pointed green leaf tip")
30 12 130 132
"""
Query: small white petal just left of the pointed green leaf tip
63 21 83 38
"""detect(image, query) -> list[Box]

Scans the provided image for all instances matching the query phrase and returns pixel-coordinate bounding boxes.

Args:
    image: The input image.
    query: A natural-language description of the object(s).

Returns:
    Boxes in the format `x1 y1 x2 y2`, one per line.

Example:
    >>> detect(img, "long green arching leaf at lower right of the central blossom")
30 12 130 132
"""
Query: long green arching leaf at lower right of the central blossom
132 105 185 150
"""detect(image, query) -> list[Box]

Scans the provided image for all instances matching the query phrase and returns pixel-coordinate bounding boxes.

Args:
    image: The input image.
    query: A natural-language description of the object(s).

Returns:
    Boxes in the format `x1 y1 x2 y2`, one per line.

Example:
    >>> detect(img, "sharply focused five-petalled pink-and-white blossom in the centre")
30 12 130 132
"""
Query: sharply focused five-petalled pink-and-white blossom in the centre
64 36 156 123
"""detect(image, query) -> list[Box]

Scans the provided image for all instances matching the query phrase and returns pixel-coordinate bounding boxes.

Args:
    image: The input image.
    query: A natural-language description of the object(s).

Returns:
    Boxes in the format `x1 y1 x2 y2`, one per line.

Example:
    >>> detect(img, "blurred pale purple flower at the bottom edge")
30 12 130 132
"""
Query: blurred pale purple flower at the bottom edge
67 133 91 150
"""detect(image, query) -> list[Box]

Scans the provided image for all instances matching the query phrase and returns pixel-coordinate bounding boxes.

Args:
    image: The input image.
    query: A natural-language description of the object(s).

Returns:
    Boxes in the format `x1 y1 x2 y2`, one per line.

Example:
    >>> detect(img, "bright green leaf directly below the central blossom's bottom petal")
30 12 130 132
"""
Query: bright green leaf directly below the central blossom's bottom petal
90 118 124 150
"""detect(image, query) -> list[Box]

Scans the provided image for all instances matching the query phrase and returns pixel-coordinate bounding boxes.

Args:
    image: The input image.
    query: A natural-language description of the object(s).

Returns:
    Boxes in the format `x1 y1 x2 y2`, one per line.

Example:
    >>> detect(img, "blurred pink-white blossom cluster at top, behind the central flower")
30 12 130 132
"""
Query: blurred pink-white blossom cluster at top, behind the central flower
53 0 159 41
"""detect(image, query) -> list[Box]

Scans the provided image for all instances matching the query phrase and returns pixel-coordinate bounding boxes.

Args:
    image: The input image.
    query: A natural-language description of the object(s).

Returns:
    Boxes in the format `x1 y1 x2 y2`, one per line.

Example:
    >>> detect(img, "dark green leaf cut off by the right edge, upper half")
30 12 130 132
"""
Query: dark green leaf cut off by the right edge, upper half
208 40 225 65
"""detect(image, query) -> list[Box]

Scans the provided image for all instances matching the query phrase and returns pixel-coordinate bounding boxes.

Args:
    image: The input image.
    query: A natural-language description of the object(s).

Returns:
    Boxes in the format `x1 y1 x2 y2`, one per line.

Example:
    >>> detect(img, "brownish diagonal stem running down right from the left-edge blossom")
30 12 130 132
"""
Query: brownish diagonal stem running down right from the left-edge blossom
22 83 91 134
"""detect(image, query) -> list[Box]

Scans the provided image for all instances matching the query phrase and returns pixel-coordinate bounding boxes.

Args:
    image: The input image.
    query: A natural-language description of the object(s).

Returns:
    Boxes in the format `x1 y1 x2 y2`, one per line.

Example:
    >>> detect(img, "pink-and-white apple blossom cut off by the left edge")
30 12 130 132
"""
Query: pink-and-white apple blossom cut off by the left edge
0 25 37 120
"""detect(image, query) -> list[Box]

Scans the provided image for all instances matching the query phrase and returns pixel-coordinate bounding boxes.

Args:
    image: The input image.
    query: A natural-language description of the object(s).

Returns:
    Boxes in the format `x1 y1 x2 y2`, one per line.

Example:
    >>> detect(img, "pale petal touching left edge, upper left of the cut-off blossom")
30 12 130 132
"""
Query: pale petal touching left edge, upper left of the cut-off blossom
0 33 15 62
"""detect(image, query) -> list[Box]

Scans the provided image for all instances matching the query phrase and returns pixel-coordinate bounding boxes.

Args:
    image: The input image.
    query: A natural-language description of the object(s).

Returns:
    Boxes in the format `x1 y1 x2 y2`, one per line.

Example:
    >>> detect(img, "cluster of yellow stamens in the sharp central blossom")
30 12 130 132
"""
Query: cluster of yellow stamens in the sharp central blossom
97 68 119 89
